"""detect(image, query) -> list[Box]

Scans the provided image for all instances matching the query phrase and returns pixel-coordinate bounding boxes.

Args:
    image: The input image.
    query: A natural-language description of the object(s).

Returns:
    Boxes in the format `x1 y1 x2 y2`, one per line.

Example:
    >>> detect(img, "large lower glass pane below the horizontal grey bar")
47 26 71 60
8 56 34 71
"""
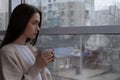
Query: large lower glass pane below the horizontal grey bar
36 34 120 80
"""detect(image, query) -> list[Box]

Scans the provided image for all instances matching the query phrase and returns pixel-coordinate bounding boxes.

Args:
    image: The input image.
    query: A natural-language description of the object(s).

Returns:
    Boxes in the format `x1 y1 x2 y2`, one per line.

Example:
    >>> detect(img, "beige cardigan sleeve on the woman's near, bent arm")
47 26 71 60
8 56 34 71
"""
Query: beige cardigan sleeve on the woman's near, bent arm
0 50 40 80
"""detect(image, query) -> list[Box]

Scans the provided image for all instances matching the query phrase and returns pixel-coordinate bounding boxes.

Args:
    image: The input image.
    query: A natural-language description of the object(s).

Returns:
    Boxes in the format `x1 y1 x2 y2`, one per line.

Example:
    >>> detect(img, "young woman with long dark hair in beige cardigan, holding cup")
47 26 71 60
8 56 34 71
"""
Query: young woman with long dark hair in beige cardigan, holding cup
0 4 54 80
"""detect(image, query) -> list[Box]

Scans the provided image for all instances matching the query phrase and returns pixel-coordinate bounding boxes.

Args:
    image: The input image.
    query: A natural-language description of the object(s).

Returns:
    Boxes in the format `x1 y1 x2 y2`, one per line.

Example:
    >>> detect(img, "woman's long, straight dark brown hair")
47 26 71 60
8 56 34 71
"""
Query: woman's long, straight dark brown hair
0 3 42 47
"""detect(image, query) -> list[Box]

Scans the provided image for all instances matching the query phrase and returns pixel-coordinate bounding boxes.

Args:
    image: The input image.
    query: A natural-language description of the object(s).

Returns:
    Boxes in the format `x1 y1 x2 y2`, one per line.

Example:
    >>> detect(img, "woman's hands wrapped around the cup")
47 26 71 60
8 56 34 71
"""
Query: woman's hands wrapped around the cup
35 49 54 68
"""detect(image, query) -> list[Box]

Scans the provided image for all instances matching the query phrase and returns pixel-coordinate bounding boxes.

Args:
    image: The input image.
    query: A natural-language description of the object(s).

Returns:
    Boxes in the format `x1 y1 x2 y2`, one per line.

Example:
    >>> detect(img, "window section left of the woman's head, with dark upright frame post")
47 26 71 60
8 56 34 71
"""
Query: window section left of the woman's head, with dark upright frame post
0 0 21 40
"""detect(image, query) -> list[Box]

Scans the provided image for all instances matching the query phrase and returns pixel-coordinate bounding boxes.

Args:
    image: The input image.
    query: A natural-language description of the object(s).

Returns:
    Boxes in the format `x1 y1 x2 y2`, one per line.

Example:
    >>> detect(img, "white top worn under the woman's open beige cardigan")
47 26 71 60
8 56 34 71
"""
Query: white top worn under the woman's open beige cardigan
15 44 42 80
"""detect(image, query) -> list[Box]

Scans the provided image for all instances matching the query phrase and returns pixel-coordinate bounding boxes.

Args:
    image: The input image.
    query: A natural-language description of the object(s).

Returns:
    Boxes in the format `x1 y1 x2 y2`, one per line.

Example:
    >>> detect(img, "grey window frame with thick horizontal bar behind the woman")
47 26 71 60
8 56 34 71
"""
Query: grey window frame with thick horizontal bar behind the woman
0 0 120 35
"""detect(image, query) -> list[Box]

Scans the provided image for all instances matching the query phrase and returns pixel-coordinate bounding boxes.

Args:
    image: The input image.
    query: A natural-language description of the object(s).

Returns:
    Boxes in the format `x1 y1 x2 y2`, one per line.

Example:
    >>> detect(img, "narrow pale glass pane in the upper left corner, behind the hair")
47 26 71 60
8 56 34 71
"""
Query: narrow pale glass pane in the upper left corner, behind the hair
0 0 9 30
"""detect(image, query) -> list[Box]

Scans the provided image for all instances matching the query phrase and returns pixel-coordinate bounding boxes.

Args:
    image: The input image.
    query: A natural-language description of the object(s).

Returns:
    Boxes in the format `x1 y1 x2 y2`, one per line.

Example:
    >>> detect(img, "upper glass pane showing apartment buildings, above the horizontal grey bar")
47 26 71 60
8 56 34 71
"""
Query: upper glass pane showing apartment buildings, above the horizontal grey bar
26 0 120 28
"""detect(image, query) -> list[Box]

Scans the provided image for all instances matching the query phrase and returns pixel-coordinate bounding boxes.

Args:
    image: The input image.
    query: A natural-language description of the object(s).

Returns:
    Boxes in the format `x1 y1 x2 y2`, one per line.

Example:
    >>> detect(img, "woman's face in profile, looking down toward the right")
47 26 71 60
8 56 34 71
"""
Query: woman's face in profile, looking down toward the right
23 13 40 39
